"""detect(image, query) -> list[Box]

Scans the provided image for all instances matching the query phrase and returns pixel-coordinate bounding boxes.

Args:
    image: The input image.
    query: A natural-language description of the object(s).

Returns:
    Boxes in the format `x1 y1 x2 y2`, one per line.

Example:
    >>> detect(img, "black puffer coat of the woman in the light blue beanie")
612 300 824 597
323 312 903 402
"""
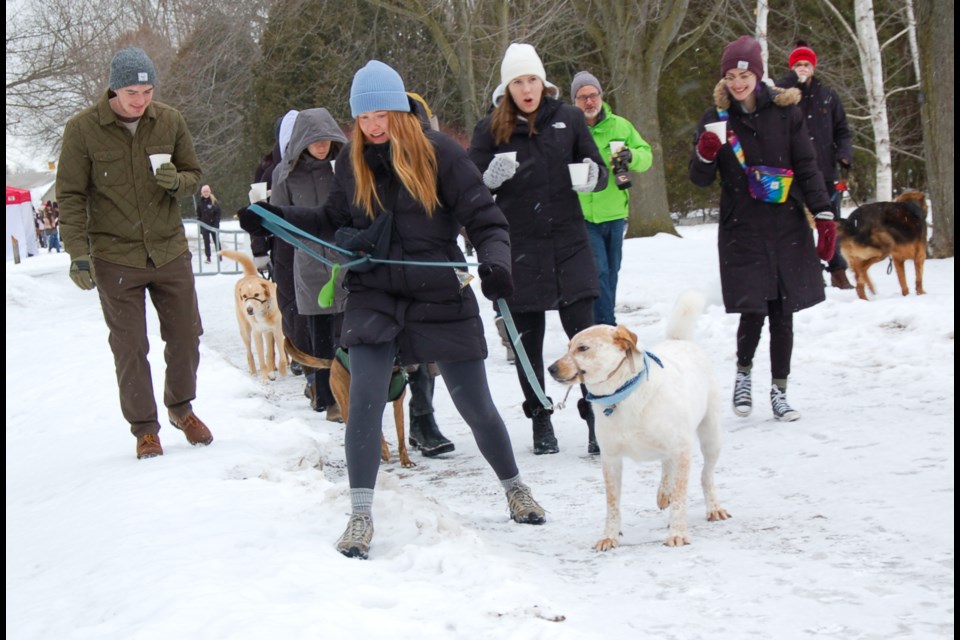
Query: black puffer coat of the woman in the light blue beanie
283 131 510 364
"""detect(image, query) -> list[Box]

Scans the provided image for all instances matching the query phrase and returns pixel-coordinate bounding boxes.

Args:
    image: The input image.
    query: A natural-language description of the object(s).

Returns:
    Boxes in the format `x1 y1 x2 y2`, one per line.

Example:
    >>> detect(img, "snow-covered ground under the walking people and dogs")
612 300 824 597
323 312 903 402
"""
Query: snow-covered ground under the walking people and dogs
6 224 955 640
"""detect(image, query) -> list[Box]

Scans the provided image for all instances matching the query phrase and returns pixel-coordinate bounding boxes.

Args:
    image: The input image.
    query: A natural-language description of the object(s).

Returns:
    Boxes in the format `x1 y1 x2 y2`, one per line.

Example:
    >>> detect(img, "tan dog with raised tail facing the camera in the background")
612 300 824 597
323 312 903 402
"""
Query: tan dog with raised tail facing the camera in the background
220 250 287 382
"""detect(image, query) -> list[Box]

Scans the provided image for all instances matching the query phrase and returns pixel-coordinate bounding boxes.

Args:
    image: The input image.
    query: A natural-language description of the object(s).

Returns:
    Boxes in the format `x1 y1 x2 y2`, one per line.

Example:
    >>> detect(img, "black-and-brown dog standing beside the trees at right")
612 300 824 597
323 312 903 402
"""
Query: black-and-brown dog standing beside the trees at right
837 191 927 300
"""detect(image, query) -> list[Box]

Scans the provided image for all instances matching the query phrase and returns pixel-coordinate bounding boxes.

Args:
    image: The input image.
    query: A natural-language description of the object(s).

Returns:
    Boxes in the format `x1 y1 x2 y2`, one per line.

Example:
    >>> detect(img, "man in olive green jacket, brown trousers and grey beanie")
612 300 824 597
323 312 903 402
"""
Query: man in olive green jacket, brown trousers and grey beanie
57 47 213 458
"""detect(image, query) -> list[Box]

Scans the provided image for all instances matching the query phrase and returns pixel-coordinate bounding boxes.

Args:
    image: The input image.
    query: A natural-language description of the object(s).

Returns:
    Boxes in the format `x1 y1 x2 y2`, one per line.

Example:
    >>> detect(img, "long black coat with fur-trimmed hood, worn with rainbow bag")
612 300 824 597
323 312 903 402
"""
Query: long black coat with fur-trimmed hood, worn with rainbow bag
690 81 830 314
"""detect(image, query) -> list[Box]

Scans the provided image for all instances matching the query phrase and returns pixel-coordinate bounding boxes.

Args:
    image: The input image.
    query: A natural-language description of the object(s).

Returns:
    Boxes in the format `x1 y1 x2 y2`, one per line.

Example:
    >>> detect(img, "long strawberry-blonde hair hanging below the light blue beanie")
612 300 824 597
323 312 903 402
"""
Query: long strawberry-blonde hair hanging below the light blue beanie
350 111 440 220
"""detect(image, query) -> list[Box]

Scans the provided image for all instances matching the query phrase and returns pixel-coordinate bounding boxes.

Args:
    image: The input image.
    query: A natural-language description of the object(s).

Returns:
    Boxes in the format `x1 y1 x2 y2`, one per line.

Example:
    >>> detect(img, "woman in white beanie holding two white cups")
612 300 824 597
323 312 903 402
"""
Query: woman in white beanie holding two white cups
470 42 607 455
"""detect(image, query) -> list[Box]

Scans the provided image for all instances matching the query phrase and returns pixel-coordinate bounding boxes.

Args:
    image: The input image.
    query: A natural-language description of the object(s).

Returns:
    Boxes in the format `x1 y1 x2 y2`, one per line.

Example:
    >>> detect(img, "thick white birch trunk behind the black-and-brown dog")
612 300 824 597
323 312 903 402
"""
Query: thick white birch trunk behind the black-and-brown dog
853 0 893 202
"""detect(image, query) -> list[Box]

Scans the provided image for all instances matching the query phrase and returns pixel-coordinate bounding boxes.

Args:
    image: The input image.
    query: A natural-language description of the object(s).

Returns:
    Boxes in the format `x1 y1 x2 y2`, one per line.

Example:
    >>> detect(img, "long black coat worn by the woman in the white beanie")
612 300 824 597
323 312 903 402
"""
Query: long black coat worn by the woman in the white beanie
467 96 607 312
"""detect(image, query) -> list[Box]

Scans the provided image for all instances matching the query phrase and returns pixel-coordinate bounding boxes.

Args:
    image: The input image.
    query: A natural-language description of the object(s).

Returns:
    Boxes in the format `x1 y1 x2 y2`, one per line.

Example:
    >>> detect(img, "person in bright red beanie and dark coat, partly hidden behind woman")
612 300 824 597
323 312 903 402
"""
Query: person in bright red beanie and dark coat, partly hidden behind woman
776 40 853 289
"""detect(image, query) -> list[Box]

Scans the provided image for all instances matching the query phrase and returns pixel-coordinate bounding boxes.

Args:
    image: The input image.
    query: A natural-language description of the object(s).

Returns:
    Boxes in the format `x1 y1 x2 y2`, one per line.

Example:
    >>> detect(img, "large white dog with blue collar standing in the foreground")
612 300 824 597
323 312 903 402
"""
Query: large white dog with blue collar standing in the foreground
549 291 730 551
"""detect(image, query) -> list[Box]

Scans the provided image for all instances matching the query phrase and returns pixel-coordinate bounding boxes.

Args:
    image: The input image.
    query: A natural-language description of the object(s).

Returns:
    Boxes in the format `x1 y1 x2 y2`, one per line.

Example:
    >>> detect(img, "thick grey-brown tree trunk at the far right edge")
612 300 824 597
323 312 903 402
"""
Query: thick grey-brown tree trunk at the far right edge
916 0 955 258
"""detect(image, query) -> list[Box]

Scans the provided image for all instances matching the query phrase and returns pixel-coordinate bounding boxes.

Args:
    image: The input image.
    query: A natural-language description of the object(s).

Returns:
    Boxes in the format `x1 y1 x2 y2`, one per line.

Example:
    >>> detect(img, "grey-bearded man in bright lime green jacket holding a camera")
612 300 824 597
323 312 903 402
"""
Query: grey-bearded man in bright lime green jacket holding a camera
570 71 653 325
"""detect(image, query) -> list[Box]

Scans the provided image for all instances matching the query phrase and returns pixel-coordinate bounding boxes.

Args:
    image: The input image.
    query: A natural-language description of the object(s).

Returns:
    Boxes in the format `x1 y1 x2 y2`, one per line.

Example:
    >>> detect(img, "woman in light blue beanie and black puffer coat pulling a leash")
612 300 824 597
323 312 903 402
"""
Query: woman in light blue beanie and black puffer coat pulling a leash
240 60 546 558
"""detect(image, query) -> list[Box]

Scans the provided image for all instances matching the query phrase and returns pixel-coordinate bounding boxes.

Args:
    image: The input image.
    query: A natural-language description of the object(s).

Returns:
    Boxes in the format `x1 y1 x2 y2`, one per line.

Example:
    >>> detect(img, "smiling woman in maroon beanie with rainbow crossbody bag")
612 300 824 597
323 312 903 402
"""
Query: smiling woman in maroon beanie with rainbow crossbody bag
689 36 836 422
